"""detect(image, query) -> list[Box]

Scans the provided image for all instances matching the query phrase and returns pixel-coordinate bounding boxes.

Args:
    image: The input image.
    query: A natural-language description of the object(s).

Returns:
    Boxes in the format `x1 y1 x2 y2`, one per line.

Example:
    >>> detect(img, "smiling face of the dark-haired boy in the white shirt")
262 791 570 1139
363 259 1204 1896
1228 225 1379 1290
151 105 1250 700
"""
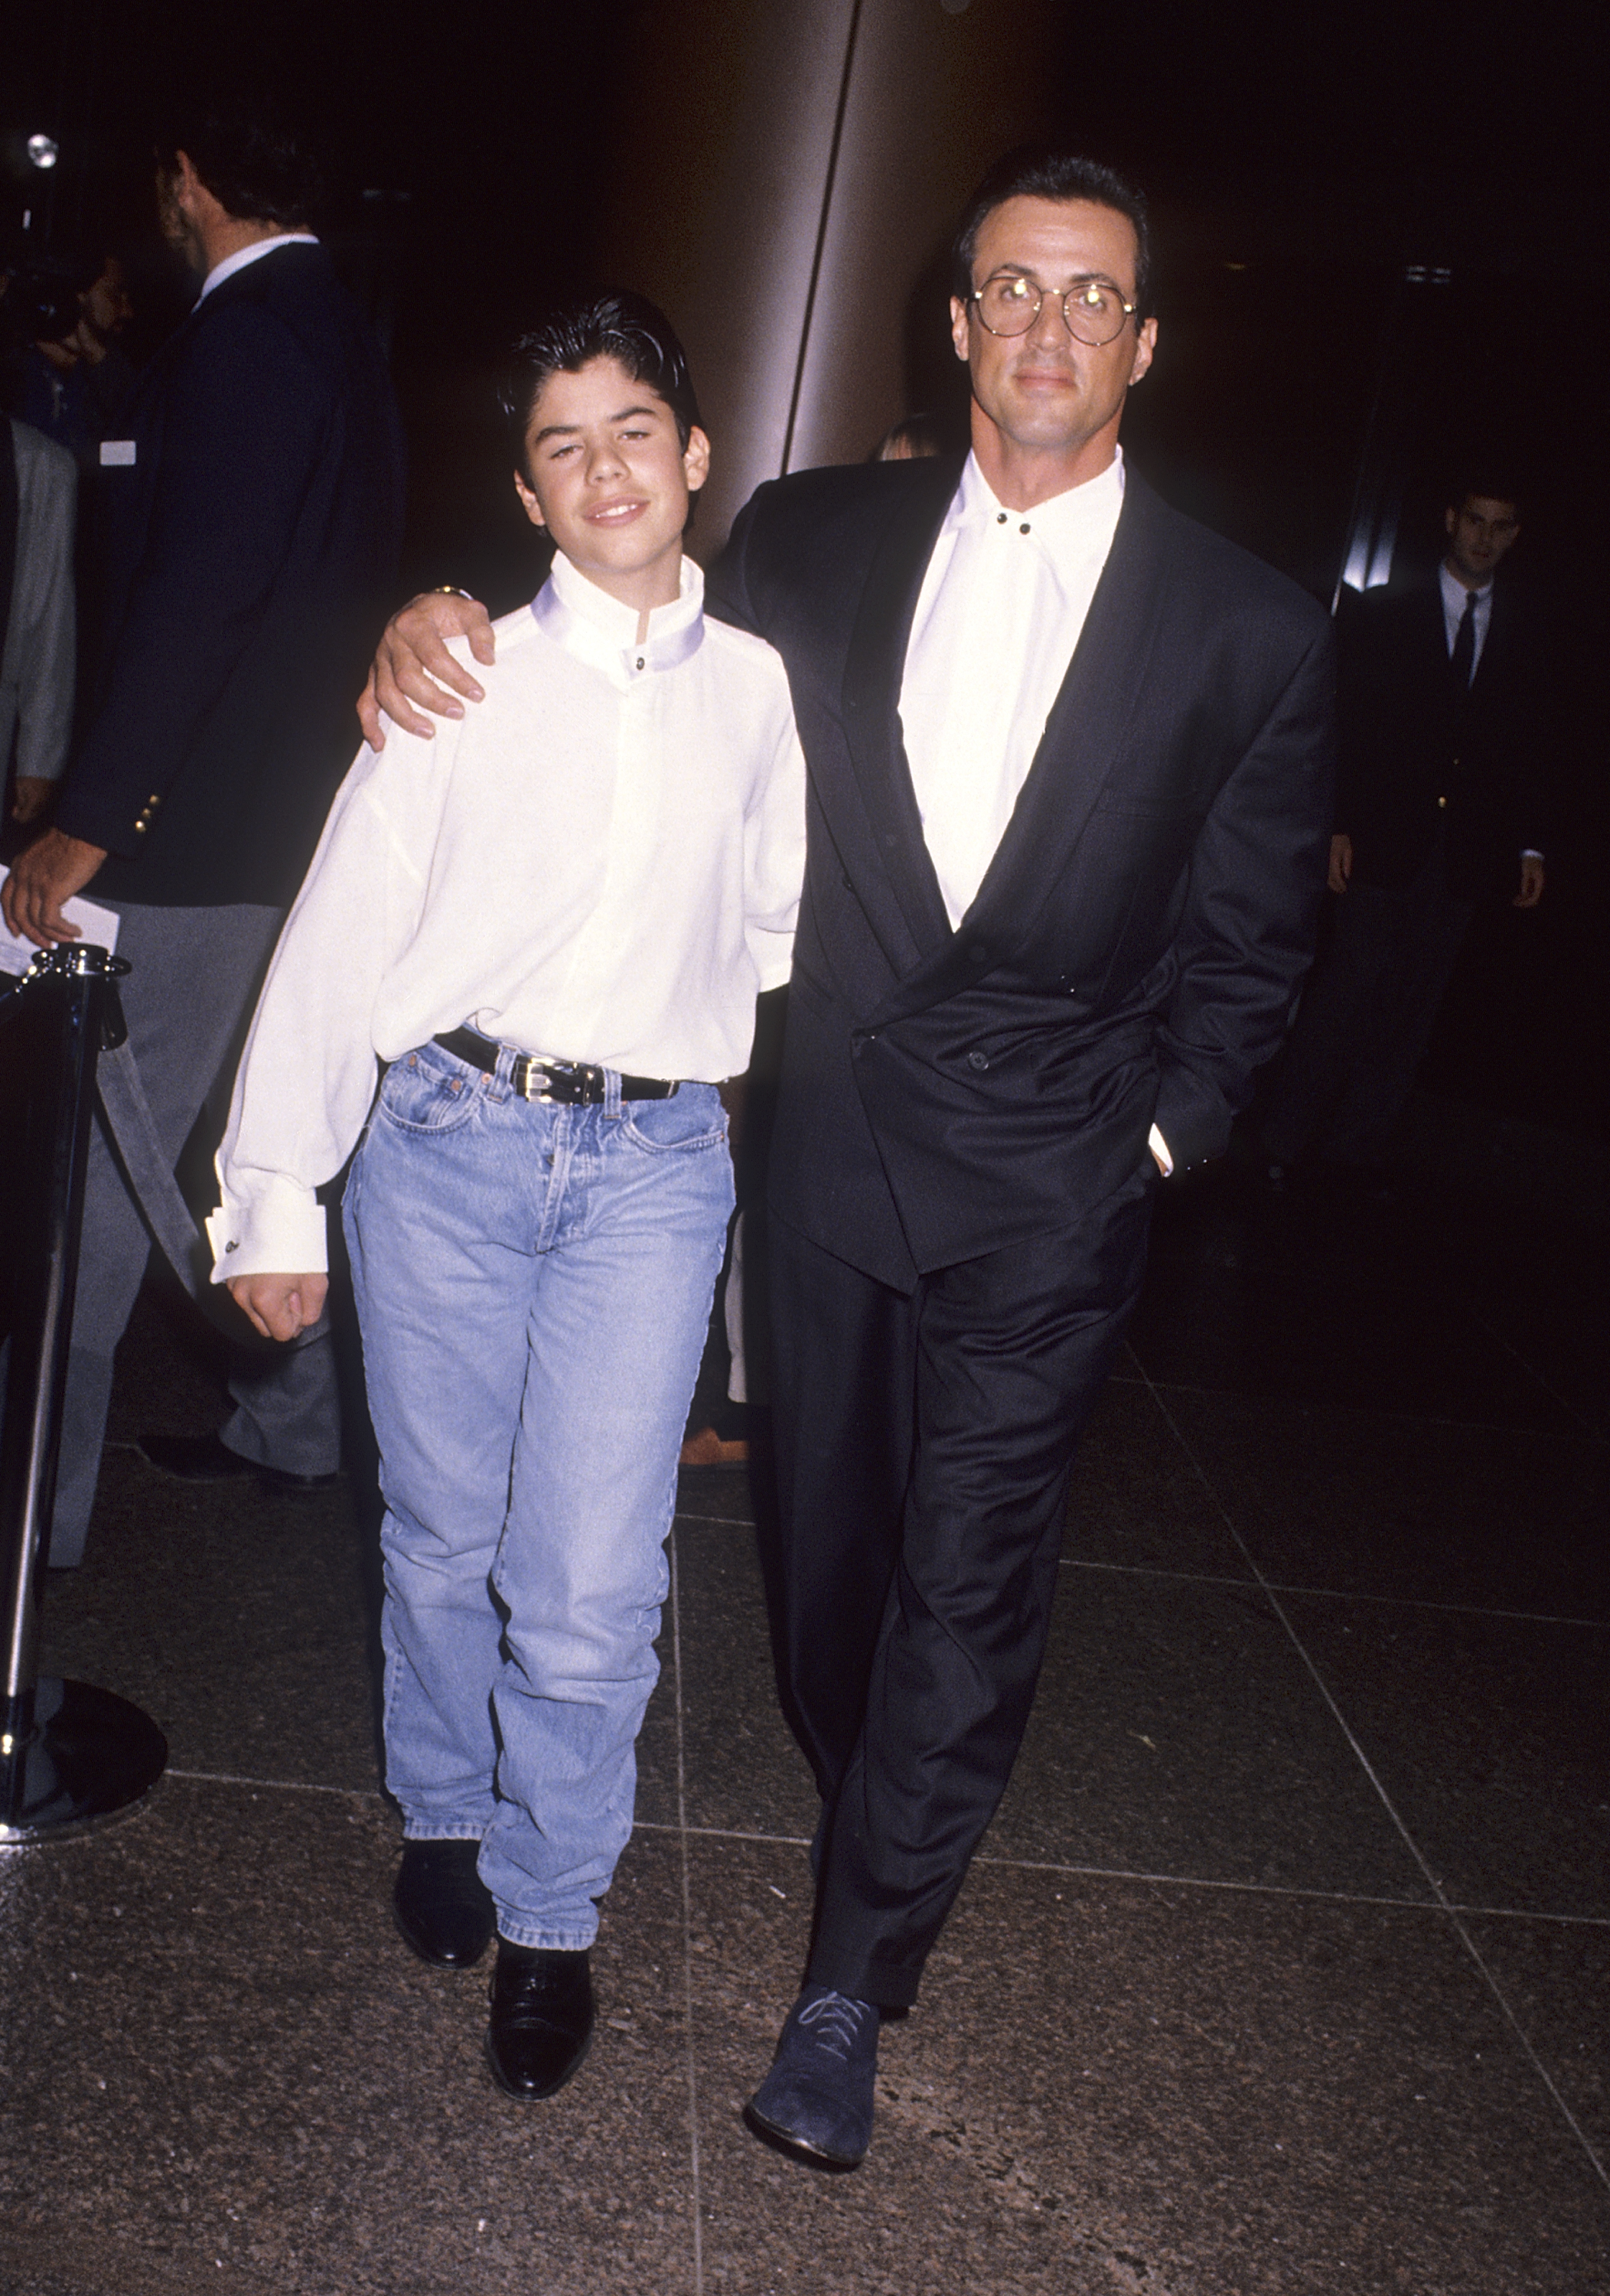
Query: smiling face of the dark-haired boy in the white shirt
514 358 709 606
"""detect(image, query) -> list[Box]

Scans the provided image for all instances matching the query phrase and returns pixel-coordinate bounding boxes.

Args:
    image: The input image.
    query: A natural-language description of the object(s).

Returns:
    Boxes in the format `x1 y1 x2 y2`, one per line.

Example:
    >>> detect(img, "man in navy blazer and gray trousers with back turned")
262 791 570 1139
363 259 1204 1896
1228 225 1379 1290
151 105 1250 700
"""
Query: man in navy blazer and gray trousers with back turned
5 101 402 1564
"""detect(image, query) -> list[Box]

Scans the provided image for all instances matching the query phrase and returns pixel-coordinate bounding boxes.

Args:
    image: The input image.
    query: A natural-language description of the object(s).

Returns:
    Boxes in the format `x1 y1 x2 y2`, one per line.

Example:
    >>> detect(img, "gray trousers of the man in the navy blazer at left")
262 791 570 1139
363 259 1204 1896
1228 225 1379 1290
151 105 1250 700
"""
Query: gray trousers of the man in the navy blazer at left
51 905 340 1566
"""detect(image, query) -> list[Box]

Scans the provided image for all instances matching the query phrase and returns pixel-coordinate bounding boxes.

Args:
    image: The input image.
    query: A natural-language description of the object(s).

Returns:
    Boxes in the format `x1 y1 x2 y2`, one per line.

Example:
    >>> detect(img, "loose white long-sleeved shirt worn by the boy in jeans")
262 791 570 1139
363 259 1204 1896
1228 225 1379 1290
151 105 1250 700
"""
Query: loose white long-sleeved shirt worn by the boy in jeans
207 558 803 1281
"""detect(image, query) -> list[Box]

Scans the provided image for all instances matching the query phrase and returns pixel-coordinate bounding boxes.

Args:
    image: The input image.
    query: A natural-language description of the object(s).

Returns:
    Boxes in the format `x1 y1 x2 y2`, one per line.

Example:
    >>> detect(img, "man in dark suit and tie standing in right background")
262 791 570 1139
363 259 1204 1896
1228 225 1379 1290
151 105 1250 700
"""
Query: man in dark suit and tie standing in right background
1263 487 1543 1180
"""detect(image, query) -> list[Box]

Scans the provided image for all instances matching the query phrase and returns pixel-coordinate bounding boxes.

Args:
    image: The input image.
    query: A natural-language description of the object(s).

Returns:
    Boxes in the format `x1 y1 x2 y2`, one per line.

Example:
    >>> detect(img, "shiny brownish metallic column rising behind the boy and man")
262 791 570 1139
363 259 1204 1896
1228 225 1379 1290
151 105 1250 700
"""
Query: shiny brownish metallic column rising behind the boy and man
590 0 1057 556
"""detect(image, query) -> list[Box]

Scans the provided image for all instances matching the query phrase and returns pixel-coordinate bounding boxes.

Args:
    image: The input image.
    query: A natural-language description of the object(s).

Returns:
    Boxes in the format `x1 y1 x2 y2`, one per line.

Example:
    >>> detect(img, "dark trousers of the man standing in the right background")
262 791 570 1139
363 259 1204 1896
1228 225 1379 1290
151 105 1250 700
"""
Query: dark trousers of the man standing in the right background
1263 840 1475 1166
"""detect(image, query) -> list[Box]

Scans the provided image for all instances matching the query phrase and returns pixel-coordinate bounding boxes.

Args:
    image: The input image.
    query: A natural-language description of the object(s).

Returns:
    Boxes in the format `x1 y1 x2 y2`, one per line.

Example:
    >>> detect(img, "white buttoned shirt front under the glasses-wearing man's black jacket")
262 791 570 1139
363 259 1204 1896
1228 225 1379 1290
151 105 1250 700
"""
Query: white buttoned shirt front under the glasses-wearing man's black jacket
901 455 1123 925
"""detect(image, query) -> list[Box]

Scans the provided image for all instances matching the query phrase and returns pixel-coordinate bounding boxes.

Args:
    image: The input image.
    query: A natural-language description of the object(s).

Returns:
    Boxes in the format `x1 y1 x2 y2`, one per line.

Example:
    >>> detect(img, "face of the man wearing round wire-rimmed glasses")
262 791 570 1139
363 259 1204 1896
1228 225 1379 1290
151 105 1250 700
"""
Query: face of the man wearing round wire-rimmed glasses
951 197 1158 478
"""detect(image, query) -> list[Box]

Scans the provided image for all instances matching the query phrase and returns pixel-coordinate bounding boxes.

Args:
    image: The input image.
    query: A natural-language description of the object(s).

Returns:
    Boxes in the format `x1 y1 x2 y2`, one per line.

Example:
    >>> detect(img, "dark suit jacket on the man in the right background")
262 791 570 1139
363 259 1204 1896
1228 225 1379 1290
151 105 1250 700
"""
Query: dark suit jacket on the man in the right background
1335 579 1546 900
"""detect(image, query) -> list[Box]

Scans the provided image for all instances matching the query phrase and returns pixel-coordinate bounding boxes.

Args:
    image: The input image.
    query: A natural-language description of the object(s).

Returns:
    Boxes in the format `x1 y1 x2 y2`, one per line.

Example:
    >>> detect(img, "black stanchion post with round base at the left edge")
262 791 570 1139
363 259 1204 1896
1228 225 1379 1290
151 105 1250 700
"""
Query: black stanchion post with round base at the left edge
0 944 168 1848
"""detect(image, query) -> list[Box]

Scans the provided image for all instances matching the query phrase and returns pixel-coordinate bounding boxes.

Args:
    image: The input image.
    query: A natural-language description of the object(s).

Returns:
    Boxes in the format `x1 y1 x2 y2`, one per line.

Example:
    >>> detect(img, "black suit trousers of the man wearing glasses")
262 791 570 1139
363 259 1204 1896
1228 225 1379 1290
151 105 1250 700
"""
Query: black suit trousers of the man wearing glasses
767 1157 1158 2009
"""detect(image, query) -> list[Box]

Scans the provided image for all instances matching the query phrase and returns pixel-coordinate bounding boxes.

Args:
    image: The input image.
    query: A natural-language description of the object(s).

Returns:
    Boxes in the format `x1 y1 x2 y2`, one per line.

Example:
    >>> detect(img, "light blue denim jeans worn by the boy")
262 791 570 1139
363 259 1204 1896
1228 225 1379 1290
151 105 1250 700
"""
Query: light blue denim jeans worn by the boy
344 1045 732 1952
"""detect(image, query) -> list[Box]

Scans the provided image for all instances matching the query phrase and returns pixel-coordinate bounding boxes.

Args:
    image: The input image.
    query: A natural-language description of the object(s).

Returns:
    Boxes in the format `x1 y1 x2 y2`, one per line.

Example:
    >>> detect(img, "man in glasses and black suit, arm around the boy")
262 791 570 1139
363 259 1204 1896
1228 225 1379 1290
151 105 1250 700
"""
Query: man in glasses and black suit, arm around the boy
360 152 1332 2165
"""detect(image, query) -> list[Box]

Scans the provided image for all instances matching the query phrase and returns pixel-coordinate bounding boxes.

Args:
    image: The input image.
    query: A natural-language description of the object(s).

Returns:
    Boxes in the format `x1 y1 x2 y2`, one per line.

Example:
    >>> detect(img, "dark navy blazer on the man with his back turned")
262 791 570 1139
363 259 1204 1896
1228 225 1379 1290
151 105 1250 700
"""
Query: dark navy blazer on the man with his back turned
55 246 402 905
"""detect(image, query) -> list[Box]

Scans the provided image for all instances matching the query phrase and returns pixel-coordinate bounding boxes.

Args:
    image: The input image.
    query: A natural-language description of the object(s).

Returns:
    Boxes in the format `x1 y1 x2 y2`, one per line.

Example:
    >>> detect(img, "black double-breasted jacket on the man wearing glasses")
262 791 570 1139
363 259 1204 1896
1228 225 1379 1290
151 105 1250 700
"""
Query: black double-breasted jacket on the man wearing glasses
709 461 1335 1288
